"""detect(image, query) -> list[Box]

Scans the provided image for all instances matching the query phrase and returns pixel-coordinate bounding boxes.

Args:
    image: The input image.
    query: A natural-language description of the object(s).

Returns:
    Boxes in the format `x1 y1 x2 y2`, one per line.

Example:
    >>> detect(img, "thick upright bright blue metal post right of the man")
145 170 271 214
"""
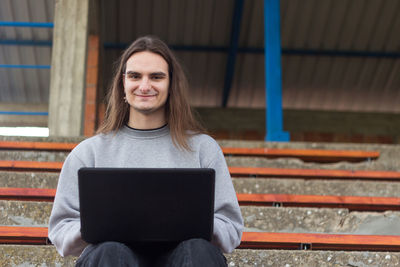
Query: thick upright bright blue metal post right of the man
264 0 290 141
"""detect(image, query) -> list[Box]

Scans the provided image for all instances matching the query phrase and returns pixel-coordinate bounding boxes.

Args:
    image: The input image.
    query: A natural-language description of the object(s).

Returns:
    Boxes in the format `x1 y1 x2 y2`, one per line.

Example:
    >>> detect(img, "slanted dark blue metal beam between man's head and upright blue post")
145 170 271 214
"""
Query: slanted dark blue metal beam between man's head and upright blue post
222 0 244 107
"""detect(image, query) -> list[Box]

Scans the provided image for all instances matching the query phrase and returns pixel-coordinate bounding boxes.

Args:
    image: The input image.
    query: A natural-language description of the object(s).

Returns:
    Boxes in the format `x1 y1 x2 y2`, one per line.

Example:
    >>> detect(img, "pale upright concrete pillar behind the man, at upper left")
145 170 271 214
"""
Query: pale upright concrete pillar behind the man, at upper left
49 0 90 136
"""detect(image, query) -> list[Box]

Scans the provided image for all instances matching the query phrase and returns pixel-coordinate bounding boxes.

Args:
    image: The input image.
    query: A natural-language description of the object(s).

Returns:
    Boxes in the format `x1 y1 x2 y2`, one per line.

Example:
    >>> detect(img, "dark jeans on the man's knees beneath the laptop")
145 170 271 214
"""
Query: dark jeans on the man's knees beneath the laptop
76 239 227 267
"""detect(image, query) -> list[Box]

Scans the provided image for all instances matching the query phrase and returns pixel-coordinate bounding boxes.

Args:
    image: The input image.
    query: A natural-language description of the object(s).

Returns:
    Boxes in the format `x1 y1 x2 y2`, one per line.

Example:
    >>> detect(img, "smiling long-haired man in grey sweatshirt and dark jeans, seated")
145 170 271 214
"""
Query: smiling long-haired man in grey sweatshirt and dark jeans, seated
49 36 243 266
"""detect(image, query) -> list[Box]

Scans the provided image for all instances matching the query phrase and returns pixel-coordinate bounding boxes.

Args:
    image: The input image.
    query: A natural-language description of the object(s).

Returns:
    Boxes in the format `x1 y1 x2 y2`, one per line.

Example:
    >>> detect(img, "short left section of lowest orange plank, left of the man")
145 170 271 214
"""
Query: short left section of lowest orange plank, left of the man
0 226 48 245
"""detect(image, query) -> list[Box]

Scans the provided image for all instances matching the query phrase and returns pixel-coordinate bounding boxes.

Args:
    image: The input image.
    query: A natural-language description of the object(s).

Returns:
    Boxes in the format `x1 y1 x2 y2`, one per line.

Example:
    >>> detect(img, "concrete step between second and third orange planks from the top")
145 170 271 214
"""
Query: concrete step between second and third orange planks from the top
0 171 400 197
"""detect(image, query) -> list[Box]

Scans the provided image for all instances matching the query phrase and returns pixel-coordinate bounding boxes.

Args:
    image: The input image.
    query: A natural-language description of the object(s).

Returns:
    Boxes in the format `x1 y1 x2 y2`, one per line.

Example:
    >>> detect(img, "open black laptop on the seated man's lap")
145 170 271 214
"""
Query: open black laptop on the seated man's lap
78 168 215 245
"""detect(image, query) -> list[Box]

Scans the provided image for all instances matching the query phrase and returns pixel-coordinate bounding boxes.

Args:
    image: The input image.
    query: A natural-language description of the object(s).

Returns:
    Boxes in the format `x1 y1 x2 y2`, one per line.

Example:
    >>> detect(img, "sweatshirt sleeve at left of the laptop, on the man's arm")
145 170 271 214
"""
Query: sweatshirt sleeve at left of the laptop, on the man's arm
49 152 88 257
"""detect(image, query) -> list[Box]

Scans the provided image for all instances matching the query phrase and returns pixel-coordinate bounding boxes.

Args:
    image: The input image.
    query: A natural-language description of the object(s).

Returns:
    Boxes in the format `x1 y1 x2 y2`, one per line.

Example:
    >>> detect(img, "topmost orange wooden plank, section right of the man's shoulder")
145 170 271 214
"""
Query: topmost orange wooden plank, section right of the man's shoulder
222 147 380 162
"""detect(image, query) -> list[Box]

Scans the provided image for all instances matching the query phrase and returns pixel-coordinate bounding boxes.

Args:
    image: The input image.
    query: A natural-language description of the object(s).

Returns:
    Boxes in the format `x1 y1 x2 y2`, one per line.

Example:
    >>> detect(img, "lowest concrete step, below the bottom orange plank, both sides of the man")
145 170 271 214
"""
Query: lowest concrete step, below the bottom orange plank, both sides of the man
0 245 400 267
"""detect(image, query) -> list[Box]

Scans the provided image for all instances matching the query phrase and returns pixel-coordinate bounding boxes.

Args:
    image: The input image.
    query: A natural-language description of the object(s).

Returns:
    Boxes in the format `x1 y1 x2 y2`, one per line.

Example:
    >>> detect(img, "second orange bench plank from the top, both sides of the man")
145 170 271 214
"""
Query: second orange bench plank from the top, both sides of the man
0 160 400 181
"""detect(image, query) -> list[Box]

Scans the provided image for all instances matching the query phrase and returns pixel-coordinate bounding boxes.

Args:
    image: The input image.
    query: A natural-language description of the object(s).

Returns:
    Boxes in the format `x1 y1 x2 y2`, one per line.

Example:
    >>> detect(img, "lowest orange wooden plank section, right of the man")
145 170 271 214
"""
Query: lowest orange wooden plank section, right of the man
239 232 400 251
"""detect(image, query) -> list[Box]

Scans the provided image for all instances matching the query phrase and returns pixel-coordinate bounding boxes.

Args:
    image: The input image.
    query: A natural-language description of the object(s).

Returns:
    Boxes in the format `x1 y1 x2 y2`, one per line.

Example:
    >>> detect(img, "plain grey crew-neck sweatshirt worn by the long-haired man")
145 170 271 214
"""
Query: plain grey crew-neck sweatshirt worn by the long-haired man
49 126 243 256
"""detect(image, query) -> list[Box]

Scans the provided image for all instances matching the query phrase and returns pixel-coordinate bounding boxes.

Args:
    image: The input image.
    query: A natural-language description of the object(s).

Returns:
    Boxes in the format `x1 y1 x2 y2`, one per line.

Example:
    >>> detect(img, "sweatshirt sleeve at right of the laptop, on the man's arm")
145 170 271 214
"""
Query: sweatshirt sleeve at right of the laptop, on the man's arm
205 140 243 253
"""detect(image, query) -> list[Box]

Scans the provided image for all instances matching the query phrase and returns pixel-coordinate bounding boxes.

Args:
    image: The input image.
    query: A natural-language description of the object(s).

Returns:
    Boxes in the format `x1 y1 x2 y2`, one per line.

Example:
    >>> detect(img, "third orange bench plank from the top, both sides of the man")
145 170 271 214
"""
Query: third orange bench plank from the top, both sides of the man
0 187 400 211
